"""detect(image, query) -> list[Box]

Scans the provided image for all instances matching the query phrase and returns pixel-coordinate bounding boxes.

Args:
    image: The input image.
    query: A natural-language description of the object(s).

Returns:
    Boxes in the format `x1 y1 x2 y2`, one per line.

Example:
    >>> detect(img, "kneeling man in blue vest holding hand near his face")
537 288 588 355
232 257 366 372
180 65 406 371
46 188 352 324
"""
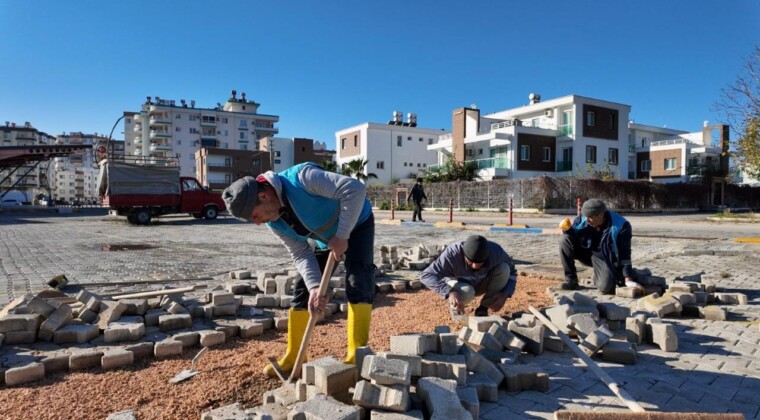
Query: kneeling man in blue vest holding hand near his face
559 198 638 294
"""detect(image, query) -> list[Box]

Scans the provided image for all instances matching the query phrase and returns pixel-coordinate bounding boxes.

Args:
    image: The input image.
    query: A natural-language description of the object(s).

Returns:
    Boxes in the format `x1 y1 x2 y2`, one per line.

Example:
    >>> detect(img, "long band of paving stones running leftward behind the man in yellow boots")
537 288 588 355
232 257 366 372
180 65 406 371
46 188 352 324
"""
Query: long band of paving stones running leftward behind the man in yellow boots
0 264 419 386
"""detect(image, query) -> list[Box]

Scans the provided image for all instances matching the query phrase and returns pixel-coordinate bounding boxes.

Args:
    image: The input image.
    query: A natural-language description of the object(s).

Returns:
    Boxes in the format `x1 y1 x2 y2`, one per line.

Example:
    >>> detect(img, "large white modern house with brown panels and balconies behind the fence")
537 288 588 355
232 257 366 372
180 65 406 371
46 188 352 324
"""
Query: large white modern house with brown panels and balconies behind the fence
427 94 631 180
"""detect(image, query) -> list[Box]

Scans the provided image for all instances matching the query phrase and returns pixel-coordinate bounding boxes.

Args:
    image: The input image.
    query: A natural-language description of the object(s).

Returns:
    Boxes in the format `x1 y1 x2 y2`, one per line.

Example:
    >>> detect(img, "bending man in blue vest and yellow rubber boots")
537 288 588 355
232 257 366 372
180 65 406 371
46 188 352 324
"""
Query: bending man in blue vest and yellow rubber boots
222 163 375 378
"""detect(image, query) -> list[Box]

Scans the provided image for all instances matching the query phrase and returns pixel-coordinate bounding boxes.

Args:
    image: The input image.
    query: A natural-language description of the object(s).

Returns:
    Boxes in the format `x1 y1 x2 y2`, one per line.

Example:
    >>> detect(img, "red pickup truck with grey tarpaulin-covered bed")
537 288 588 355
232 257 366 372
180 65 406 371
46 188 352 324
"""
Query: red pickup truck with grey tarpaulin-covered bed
98 158 225 225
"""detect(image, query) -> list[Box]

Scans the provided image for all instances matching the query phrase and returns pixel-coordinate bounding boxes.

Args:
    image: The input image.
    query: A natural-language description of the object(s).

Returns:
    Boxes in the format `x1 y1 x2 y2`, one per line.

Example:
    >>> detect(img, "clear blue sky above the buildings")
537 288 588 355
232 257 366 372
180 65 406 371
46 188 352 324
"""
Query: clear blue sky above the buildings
0 0 760 147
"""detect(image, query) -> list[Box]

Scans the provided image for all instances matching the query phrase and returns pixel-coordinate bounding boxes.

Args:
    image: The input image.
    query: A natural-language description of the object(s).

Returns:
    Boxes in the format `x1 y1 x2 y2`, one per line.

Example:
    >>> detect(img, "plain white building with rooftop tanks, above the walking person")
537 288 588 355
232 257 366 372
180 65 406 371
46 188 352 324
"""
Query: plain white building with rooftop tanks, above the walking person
335 111 443 184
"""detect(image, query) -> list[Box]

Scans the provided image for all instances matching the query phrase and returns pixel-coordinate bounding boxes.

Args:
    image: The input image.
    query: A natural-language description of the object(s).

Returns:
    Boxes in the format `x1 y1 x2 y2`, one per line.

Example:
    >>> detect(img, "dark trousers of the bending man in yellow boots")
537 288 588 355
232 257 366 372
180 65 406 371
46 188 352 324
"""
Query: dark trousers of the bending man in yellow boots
290 214 375 309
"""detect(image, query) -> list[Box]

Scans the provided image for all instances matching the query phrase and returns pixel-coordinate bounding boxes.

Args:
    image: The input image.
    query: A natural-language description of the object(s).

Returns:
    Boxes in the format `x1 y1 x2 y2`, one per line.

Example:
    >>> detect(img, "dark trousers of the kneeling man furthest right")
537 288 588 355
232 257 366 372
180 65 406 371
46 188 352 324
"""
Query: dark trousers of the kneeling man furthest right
559 234 622 295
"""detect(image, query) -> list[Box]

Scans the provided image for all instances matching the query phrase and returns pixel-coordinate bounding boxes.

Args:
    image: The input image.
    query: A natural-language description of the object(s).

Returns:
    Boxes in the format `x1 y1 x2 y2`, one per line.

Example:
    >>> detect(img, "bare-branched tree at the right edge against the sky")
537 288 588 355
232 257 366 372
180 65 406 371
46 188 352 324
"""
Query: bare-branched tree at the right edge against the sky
713 46 760 178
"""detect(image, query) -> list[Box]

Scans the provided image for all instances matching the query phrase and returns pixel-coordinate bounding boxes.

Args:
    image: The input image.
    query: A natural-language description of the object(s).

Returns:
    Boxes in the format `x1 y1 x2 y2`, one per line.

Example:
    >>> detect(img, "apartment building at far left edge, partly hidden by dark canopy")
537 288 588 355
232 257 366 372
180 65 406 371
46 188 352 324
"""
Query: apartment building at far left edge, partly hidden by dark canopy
0 121 55 202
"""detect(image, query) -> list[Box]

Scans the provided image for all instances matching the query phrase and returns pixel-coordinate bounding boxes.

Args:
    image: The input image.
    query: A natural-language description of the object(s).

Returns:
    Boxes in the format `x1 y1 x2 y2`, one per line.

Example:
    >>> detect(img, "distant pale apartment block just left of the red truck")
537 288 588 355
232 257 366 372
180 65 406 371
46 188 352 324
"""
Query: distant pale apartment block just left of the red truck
48 132 107 203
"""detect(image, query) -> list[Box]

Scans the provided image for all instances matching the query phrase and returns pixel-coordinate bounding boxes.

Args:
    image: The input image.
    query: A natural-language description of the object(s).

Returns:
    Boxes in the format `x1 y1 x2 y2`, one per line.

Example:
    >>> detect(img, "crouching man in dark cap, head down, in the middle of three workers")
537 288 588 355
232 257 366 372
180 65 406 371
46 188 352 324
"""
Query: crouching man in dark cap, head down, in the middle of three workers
420 235 517 319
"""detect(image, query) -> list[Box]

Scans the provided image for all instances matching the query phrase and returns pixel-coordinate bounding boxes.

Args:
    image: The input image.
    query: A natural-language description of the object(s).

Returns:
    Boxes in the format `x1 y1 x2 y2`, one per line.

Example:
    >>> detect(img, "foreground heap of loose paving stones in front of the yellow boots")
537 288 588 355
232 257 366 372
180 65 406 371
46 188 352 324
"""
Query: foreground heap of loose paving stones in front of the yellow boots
208 316 549 420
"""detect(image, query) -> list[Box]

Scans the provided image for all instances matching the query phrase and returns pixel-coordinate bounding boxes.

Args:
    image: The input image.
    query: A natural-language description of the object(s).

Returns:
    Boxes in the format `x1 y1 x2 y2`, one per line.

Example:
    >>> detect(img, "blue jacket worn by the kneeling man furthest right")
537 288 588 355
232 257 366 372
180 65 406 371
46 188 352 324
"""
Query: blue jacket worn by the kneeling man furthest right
569 210 633 283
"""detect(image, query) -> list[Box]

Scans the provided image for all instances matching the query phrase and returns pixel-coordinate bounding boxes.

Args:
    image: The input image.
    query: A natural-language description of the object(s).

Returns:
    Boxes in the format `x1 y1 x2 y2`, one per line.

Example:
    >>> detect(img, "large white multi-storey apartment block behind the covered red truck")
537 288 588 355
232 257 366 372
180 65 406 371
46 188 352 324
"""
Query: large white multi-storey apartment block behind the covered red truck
124 90 280 176
